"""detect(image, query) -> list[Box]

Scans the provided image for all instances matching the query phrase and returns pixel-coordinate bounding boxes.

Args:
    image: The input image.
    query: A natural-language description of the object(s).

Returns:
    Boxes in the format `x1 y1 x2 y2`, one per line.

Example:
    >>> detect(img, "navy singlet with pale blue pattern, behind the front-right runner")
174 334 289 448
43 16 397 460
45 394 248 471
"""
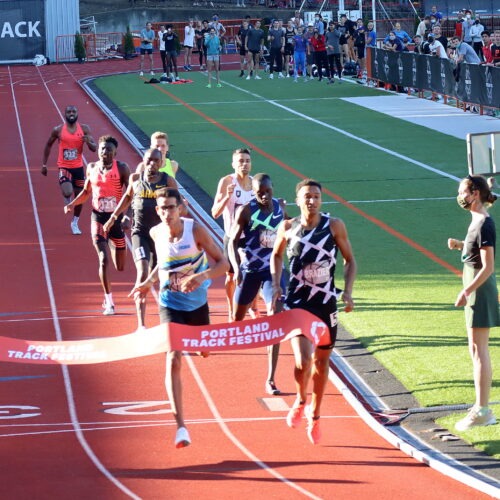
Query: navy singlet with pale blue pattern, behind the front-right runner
241 198 284 271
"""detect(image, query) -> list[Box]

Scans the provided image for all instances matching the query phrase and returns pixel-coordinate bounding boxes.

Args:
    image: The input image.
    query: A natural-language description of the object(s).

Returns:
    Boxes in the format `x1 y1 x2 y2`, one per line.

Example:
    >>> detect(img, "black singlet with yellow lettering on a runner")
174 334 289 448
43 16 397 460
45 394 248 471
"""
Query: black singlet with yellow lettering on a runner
132 172 168 236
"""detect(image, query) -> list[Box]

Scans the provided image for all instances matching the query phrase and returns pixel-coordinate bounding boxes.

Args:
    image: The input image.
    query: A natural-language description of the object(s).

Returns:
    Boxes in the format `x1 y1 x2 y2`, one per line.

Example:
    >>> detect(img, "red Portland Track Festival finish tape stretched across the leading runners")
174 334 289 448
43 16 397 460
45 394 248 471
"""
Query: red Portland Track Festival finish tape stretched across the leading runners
0 309 330 365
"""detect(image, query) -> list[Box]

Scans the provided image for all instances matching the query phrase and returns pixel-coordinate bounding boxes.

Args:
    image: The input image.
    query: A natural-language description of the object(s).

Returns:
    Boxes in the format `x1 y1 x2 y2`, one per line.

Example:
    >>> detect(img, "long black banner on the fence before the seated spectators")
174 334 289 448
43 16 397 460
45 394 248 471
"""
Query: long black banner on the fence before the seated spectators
368 48 500 108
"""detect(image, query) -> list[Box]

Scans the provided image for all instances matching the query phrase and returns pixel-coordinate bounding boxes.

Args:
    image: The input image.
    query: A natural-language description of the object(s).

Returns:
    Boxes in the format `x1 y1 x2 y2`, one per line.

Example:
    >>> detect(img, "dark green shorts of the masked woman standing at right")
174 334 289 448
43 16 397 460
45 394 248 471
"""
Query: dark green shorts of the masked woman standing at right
462 266 500 328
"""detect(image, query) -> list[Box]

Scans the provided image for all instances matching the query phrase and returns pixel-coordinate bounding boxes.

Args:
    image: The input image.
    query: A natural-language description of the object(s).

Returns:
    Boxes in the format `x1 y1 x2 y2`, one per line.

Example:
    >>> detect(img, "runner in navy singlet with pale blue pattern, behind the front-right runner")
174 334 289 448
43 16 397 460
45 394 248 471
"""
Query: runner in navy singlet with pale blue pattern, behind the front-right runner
228 174 285 396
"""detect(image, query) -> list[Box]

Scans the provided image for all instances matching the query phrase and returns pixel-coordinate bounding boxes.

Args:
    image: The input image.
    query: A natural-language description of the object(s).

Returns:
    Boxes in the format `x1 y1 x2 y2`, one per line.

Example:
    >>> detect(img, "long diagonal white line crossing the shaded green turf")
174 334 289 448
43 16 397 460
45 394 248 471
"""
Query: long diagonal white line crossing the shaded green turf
223 81 460 182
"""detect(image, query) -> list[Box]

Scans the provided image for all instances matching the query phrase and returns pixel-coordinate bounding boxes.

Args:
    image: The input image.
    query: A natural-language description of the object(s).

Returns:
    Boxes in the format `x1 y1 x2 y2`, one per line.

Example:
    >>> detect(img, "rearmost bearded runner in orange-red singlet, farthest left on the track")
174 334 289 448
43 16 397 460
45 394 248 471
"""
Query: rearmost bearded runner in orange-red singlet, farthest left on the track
42 106 97 234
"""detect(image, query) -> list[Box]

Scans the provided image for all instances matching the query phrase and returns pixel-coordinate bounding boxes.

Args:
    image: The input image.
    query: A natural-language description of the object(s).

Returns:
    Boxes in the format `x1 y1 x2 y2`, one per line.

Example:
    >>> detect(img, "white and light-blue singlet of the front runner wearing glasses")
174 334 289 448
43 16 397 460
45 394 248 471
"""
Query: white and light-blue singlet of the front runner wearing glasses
151 217 211 311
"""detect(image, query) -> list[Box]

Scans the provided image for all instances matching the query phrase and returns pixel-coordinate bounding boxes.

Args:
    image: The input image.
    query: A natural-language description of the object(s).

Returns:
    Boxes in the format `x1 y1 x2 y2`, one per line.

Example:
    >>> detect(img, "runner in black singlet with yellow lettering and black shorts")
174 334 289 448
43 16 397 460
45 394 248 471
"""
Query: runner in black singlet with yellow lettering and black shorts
104 149 177 330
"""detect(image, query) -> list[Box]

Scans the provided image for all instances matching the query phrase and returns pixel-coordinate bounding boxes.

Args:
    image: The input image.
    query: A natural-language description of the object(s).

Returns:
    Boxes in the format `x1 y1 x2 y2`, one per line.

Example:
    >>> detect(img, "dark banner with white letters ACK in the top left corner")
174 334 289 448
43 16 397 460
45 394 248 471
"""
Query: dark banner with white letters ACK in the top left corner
0 0 45 63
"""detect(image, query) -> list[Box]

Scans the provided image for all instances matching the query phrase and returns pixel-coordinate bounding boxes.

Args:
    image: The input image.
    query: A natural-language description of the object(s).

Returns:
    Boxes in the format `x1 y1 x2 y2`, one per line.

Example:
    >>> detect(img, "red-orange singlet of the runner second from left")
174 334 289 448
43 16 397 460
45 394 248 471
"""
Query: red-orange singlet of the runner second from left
89 160 123 213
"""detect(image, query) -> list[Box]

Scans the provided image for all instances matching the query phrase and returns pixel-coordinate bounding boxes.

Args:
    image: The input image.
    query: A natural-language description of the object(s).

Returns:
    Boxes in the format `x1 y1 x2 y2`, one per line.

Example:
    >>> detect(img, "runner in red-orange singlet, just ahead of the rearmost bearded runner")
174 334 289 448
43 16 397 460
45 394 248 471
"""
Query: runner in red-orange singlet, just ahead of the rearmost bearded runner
64 135 130 316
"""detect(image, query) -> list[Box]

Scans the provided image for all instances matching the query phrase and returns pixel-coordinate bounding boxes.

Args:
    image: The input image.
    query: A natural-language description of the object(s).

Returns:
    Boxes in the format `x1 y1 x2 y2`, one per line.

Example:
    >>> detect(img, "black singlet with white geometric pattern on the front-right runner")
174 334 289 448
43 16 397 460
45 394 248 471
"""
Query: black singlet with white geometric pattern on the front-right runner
286 214 341 309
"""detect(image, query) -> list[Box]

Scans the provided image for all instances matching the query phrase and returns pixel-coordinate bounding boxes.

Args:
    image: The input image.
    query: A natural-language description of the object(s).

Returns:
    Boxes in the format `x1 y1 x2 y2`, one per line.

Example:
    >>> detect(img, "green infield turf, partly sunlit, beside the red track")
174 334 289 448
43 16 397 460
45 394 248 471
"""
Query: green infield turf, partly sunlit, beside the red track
92 71 500 457
